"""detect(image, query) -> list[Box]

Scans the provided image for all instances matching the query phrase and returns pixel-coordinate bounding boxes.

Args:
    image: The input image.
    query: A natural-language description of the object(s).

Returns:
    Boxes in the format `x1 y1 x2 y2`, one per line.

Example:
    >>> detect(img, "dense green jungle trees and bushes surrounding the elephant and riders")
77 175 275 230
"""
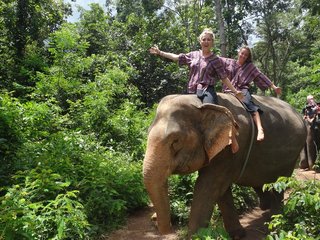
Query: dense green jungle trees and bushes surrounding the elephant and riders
0 0 320 239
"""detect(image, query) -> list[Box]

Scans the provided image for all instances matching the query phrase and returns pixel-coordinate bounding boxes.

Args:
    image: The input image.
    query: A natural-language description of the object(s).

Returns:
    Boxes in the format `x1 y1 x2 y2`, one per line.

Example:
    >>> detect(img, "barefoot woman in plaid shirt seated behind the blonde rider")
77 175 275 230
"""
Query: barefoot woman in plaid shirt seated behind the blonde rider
221 46 281 141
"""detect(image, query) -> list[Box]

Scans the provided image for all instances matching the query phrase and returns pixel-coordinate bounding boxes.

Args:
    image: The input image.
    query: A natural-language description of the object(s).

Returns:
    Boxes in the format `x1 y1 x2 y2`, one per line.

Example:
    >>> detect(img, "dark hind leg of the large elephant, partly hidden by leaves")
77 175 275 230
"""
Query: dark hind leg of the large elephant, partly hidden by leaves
254 187 283 215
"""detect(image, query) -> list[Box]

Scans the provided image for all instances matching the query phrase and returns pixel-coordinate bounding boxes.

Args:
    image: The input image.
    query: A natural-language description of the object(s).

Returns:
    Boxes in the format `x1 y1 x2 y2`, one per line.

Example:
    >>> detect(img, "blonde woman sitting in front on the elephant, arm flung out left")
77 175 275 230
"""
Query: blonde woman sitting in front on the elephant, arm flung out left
149 28 243 153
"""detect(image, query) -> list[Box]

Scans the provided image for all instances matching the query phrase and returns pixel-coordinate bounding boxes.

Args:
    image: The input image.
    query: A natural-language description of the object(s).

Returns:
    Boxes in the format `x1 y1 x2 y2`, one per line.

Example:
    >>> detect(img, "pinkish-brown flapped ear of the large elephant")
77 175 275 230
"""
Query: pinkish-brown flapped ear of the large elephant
198 103 239 161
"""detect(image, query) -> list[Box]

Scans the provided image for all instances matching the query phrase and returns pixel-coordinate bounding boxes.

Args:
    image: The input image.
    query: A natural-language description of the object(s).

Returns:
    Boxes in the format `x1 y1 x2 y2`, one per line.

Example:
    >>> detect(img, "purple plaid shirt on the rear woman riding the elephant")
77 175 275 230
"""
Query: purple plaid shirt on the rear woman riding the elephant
221 58 272 91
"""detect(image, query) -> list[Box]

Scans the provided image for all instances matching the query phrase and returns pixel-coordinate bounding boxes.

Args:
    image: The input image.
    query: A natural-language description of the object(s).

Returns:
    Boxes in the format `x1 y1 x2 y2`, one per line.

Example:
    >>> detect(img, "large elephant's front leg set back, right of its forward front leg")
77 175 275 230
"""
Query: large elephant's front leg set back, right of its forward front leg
218 187 246 239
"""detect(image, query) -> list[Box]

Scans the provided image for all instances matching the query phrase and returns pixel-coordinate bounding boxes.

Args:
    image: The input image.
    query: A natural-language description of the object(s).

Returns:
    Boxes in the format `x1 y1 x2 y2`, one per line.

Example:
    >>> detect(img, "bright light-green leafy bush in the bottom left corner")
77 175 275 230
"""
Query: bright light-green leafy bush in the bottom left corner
0 169 89 239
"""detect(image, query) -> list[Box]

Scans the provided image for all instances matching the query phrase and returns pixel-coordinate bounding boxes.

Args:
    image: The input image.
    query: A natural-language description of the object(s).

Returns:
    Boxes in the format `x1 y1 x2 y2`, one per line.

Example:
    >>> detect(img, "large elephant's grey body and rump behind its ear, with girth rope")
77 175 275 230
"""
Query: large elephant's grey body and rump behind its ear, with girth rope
218 93 307 185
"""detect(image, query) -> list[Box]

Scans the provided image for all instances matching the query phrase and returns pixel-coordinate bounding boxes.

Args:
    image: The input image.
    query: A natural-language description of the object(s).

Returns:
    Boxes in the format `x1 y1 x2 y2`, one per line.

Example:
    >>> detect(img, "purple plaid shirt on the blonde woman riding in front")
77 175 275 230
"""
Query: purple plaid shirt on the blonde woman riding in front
179 51 227 93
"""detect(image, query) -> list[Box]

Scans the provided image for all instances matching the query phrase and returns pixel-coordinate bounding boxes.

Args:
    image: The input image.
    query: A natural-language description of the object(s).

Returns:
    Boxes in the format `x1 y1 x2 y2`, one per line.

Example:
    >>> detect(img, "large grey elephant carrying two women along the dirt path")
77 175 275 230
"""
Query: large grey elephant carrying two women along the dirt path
143 92 307 238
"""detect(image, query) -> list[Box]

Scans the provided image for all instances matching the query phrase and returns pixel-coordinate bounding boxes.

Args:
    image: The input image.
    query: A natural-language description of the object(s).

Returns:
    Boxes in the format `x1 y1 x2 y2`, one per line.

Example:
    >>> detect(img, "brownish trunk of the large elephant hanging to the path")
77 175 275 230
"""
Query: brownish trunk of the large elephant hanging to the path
143 151 172 234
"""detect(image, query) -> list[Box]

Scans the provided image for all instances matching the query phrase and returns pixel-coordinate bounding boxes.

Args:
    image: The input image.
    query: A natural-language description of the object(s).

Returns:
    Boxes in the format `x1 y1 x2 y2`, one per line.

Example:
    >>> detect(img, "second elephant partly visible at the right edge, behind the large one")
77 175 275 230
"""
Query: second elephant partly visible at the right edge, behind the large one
299 116 320 170
